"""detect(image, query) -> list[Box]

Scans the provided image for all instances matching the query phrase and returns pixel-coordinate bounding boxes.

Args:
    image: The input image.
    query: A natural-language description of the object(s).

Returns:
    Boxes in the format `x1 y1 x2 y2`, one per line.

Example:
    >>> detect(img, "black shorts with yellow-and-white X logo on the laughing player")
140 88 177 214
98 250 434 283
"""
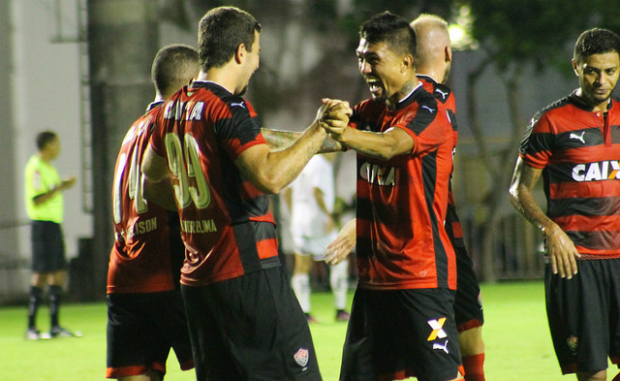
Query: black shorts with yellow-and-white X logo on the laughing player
340 288 462 381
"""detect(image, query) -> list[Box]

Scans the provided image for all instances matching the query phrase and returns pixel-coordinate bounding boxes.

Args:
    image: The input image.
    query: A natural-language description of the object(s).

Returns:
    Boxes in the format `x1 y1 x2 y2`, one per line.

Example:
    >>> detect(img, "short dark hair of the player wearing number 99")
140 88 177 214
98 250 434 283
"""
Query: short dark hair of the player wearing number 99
198 7 261 71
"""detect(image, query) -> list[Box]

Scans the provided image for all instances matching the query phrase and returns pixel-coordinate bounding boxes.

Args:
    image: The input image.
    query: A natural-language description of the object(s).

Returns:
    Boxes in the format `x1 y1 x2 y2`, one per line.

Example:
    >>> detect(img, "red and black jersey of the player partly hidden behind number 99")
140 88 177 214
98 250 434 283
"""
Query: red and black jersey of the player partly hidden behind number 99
107 102 185 293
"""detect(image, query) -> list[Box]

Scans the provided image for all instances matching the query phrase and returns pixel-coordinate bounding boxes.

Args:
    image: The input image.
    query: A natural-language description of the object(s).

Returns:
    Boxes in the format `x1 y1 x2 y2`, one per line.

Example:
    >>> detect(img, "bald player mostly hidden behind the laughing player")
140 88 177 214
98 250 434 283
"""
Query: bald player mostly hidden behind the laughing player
411 14 485 381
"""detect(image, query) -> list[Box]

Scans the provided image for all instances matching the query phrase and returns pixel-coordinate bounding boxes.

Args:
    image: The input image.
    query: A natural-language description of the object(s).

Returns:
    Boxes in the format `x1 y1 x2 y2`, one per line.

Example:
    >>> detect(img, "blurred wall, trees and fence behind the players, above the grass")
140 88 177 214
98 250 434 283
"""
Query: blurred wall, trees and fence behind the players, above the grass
0 0 620 304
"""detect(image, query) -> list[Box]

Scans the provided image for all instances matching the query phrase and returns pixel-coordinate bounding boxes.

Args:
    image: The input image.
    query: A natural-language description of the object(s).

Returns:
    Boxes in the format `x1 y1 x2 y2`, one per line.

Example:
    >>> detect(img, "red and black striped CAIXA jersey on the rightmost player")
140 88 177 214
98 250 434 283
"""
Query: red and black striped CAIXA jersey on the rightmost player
520 92 620 257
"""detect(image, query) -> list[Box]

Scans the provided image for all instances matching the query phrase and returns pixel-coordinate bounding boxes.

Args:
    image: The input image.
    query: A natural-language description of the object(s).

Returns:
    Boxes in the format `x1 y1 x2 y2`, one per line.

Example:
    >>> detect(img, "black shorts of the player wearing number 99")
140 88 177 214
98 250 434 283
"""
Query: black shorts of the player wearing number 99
181 266 321 381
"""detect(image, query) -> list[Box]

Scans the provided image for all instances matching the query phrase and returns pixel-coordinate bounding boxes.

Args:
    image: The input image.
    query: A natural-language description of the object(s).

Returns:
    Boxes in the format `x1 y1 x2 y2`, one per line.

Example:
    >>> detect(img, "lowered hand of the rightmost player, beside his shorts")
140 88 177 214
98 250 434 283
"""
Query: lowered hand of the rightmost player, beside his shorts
545 224 581 279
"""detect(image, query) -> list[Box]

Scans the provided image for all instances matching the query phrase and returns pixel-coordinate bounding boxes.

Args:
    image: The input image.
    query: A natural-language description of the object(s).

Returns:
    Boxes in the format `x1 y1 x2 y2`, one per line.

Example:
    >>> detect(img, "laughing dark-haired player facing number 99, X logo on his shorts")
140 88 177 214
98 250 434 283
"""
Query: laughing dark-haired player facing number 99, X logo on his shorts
325 12 462 381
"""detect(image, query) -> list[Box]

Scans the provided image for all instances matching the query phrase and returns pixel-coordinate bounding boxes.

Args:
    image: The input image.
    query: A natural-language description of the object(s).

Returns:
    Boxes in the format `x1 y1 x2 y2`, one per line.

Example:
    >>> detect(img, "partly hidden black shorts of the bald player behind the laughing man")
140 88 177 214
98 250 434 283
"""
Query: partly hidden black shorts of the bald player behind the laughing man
454 247 484 332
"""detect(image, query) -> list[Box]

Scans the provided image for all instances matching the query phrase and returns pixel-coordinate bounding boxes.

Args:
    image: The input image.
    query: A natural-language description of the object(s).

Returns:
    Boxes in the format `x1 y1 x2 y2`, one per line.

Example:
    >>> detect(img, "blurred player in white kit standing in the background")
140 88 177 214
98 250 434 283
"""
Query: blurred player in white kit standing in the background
288 153 349 323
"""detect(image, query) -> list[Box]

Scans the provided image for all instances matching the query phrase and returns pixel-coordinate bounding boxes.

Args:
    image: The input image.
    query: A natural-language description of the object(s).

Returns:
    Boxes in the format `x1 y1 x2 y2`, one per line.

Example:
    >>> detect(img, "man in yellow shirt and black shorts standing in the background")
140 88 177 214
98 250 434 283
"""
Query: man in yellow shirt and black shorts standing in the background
24 131 80 340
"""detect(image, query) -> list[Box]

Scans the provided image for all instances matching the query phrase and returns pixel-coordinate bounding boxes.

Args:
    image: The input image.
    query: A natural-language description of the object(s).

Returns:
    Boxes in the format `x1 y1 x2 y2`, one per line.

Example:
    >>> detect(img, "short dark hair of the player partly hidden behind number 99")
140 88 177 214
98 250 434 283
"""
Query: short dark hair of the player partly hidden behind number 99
151 44 200 94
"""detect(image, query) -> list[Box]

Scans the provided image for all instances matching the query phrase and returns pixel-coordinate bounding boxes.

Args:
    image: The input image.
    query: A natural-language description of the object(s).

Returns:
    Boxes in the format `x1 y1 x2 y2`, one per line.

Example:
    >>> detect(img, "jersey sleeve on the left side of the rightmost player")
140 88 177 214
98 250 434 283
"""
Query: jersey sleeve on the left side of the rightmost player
519 110 554 169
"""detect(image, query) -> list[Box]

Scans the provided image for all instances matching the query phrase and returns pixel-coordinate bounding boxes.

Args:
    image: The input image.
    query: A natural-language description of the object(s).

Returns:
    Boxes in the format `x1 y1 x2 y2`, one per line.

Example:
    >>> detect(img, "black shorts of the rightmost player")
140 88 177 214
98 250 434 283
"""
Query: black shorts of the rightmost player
545 259 620 374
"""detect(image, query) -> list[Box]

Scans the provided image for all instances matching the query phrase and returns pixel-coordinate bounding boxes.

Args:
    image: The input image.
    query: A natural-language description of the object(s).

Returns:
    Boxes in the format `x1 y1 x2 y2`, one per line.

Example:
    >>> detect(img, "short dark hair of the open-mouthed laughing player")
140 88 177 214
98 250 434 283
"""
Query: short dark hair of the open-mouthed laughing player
360 11 416 56
